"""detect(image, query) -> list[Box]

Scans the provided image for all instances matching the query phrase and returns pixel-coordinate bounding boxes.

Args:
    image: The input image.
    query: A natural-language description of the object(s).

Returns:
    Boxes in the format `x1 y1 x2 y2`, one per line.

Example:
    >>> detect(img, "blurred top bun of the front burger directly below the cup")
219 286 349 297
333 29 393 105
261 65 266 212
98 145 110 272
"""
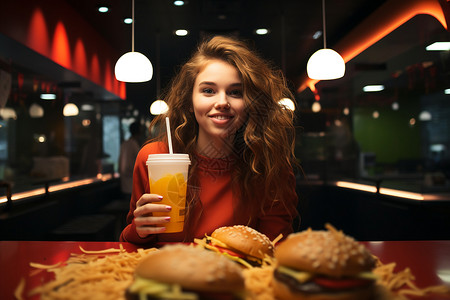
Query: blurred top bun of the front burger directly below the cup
135 244 244 292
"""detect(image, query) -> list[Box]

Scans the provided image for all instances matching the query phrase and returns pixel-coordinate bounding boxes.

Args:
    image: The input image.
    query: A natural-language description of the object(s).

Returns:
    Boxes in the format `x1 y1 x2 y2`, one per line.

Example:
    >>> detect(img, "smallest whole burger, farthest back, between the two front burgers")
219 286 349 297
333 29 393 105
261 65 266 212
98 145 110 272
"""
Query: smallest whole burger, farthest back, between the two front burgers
196 225 274 268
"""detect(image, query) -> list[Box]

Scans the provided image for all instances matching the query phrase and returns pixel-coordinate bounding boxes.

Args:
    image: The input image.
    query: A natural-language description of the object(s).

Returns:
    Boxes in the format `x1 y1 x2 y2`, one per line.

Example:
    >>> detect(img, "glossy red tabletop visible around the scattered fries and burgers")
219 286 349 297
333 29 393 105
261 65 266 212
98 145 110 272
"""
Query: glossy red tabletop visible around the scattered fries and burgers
0 241 450 300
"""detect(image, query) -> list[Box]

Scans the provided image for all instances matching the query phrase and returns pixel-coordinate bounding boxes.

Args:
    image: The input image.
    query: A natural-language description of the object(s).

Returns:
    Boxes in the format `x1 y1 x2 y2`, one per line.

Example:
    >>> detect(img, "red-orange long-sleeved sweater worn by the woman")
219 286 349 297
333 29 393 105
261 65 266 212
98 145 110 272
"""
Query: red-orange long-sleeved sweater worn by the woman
120 142 297 247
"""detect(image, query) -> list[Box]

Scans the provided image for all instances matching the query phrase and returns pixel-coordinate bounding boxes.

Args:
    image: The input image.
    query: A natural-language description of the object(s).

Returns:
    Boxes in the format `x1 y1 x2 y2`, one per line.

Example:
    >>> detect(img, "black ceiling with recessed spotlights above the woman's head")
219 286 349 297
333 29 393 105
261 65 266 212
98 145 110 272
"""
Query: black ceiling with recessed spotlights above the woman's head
63 0 385 112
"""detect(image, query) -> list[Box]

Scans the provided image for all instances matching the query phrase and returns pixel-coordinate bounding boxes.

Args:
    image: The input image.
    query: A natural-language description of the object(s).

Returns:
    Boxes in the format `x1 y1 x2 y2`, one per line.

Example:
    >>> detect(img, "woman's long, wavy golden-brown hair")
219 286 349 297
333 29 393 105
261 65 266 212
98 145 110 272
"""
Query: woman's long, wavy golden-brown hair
151 36 295 223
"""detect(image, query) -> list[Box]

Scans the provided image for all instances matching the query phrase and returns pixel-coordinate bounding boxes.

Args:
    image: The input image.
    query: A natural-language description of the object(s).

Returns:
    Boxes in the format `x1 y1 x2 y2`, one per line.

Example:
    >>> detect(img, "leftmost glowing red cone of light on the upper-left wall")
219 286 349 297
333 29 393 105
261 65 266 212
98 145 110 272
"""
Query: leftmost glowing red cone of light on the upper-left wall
27 8 49 55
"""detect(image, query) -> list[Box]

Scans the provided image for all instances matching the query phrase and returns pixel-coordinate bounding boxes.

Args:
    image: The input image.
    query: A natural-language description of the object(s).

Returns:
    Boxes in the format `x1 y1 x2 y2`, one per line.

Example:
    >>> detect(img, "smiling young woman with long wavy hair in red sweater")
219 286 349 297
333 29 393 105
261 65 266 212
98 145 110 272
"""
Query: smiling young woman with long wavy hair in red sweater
120 36 298 246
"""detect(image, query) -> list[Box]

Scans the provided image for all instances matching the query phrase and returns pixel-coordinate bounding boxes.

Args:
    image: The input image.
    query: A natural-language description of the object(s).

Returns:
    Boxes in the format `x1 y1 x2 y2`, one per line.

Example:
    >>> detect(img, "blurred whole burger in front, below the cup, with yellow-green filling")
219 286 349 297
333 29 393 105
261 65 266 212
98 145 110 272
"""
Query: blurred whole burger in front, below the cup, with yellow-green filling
125 244 244 300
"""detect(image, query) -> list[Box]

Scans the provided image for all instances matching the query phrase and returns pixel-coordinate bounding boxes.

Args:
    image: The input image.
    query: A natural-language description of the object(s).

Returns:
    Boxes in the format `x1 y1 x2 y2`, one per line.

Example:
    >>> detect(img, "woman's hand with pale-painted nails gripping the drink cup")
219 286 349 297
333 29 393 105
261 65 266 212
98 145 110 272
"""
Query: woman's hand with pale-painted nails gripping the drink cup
133 194 172 238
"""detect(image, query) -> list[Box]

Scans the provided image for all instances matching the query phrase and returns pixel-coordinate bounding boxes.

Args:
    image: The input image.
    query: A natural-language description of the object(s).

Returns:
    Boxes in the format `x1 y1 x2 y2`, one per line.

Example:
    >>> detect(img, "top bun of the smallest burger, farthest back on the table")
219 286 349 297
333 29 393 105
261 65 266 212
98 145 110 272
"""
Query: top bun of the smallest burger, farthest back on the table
211 225 274 259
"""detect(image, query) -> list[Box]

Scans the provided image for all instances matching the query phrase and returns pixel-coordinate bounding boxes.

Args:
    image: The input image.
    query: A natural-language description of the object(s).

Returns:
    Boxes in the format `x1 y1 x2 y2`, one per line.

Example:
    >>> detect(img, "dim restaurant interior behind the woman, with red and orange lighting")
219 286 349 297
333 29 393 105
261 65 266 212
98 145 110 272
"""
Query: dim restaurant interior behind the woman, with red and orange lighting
0 0 450 241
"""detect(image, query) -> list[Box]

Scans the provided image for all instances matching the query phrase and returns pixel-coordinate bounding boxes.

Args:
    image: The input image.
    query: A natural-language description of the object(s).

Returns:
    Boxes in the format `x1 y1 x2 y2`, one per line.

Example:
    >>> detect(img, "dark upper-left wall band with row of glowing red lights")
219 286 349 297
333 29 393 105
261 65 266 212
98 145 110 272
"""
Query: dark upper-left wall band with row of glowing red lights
0 1 126 99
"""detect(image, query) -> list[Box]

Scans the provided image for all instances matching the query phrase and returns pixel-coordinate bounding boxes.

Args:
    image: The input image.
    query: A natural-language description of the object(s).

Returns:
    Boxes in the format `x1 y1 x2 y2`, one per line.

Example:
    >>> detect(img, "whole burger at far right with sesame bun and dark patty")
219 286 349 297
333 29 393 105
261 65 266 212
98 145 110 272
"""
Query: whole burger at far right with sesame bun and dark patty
273 224 377 300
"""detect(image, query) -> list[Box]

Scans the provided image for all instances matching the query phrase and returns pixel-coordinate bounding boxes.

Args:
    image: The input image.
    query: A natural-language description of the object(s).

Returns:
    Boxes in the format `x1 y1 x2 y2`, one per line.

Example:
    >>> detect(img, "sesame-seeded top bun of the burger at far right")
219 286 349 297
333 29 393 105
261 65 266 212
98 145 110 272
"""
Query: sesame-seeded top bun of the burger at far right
275 226 375 277
